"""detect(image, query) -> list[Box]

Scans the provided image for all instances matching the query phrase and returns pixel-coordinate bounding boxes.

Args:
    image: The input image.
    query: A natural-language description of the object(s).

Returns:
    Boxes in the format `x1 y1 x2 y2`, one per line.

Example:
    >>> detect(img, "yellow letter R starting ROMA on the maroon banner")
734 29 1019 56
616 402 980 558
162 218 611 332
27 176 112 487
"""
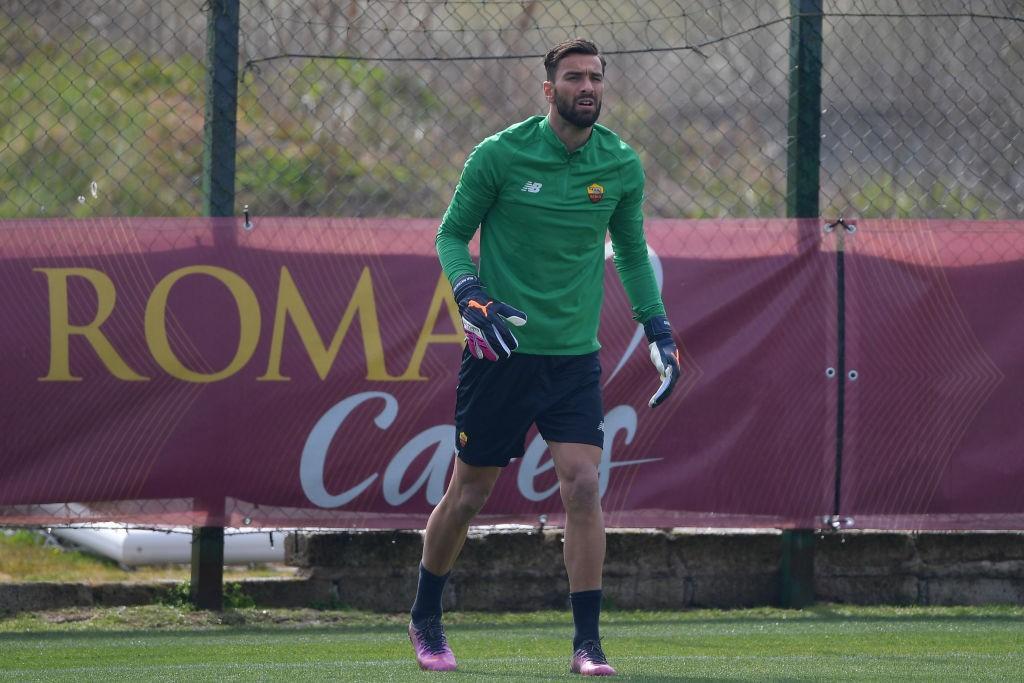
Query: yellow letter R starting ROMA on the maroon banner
33 268 150 382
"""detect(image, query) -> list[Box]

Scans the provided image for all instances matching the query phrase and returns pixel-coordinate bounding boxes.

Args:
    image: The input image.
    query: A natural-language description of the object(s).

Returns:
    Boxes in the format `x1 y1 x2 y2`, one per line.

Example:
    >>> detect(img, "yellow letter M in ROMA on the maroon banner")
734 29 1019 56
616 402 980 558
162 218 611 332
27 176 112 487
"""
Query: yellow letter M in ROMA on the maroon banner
258 266 401 382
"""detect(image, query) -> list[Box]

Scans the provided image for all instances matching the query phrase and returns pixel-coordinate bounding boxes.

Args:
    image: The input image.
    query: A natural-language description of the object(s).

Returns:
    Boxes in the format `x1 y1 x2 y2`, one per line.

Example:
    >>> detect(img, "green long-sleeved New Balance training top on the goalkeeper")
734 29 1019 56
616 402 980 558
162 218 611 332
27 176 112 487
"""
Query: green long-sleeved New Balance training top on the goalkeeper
435 116 665 355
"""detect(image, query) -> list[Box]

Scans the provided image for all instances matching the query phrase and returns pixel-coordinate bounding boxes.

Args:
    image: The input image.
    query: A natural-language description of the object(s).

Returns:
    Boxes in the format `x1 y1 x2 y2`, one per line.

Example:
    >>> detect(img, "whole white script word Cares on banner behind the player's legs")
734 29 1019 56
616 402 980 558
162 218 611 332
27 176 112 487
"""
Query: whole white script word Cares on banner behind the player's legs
299 391 660 508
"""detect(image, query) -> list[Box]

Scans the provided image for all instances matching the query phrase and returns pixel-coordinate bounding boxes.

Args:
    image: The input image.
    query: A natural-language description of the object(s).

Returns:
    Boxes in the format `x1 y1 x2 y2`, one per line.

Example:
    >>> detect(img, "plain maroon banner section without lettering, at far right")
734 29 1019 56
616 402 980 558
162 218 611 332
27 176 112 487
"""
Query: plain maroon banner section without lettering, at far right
842 220 1024 528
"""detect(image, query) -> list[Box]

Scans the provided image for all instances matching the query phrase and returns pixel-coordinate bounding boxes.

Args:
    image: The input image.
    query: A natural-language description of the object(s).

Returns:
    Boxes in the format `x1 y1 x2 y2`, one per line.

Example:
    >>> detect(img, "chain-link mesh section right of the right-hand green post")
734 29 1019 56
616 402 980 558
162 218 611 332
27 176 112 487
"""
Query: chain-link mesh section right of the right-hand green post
821 0 1024 218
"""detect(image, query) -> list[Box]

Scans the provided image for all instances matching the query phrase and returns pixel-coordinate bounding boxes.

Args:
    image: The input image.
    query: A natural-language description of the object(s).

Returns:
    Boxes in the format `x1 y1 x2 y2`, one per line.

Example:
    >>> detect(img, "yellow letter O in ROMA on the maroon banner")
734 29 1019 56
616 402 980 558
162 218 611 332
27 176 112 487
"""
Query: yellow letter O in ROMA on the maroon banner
145 265 260 383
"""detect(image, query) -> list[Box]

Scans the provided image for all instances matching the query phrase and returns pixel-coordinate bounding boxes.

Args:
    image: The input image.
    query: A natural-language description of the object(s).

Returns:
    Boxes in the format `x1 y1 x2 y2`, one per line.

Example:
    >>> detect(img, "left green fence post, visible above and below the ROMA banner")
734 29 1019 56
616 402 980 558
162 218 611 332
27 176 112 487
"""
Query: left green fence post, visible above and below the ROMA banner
189 0 239 610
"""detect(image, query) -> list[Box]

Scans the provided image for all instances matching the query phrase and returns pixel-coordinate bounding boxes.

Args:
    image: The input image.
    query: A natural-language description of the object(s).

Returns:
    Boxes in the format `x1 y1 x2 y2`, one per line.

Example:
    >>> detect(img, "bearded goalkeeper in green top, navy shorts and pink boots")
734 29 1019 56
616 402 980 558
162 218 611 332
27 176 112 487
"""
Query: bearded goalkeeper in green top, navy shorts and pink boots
409 38 679 676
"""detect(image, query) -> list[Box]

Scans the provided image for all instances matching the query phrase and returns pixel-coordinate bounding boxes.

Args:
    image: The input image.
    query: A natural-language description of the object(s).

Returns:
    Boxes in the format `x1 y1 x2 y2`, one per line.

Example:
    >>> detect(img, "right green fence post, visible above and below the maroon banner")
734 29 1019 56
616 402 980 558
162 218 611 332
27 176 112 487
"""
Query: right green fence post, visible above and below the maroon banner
779 0 821 608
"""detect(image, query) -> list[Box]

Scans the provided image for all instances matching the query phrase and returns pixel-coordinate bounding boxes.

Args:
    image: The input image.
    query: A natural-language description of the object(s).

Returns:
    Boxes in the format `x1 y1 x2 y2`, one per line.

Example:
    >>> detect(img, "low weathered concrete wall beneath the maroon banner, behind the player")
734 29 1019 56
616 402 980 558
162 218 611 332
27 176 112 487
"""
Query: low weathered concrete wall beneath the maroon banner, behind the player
287 529 1024 611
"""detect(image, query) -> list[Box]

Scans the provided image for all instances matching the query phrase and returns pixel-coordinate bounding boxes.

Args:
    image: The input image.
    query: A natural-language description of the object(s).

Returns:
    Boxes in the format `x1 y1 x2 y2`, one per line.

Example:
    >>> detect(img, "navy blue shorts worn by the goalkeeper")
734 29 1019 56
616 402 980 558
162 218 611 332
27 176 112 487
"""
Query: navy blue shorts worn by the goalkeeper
455 351 604 467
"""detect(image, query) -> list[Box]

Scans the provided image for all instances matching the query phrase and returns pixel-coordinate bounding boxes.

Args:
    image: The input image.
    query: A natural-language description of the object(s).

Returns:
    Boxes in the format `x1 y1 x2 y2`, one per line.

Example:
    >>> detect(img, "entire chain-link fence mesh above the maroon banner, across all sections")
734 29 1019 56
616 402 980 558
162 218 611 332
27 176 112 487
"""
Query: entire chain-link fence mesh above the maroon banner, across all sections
0 0 1024 218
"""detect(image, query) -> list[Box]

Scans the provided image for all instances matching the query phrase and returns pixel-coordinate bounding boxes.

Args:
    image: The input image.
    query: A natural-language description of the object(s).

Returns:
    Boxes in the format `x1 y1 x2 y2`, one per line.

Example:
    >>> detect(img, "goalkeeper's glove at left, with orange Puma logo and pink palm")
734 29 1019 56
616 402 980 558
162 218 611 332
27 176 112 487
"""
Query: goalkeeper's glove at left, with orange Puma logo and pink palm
452 275 526 360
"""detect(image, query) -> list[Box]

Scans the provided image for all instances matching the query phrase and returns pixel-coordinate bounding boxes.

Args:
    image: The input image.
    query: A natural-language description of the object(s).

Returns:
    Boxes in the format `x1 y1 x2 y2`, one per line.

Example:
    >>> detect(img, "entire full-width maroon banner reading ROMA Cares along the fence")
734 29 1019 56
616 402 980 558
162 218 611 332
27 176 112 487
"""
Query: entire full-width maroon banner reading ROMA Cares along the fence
0 217 1024 528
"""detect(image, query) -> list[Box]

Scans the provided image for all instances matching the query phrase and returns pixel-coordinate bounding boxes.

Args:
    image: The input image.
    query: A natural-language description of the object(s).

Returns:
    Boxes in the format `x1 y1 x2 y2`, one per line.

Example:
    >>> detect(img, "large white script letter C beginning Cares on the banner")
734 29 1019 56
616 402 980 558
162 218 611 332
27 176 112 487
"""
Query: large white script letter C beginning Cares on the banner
299 391 398 508
